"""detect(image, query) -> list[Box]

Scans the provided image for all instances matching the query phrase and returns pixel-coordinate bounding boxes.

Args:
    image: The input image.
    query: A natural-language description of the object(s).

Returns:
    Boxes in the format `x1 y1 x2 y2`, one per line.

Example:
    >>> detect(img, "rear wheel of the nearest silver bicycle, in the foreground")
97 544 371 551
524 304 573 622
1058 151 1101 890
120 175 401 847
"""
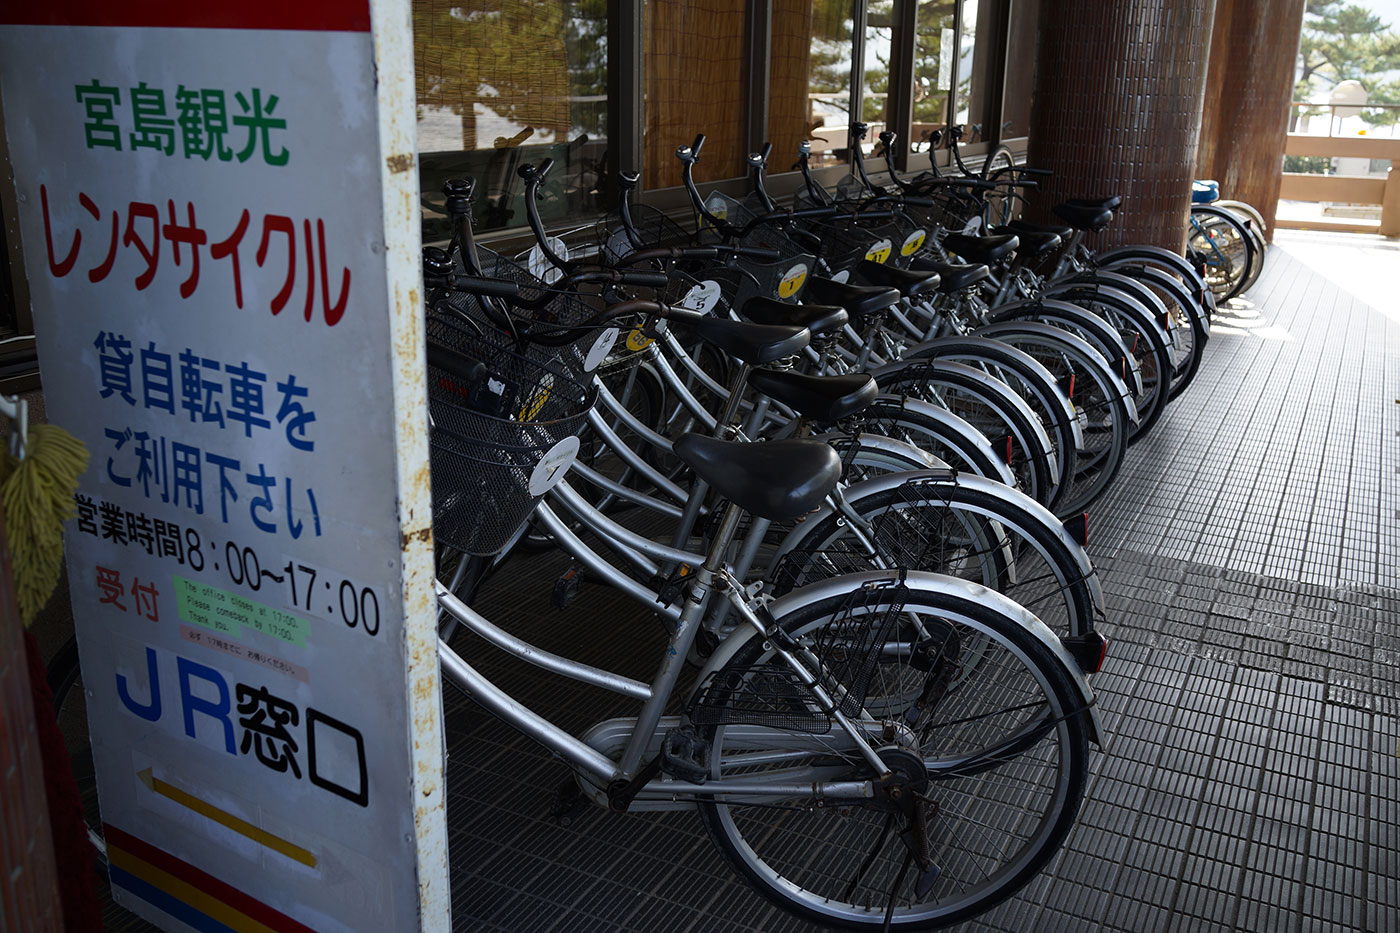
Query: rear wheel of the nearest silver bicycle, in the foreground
700 574 1088 930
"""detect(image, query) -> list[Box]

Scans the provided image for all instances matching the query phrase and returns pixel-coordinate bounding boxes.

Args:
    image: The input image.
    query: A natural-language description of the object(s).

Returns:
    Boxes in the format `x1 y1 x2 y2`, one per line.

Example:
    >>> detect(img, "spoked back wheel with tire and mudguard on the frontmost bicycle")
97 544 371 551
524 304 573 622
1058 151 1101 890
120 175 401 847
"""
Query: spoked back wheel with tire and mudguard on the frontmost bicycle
699 574 1088 930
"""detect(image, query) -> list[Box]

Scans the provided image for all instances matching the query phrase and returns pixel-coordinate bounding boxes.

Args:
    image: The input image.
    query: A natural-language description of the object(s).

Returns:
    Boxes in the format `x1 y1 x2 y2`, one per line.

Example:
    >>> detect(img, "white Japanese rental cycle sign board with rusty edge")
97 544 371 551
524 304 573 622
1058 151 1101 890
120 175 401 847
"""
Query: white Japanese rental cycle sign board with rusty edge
0 0 449 930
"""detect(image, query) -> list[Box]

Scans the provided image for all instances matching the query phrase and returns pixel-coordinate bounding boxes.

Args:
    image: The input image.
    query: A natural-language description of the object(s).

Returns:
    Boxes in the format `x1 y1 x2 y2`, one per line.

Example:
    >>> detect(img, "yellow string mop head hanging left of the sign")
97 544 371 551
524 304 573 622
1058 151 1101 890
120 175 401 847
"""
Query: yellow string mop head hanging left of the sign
0 424 88 625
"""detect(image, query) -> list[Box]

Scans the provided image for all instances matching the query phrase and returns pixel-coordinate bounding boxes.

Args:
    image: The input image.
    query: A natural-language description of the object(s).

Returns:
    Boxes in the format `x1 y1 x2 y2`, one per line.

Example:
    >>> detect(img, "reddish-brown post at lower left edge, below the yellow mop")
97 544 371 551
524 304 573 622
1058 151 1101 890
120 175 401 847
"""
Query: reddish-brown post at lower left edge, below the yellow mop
0 517 63 933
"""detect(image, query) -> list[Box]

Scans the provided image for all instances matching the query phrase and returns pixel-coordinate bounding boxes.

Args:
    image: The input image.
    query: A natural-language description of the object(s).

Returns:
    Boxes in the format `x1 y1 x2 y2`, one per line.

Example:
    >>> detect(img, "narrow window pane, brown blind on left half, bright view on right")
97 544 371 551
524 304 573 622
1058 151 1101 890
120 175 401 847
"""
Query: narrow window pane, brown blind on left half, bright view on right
769 0 855 165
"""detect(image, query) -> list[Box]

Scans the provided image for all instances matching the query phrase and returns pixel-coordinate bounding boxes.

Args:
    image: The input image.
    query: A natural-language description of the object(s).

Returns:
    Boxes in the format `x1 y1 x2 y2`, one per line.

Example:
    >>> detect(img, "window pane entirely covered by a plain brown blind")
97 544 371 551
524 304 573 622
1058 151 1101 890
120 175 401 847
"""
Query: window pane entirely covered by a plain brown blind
643 0 748 188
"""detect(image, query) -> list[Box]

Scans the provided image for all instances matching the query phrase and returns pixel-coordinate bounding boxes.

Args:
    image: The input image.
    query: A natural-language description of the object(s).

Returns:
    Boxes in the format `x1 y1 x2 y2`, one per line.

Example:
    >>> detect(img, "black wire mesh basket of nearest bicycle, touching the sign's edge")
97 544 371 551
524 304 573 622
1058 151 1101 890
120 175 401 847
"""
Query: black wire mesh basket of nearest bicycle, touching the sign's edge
427 308 595 555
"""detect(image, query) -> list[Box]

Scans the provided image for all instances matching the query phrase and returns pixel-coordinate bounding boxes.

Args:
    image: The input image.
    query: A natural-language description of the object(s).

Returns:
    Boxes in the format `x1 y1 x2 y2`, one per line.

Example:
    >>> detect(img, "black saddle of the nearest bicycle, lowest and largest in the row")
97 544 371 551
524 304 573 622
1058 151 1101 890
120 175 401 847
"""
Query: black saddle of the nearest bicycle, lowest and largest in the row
673 433 841 521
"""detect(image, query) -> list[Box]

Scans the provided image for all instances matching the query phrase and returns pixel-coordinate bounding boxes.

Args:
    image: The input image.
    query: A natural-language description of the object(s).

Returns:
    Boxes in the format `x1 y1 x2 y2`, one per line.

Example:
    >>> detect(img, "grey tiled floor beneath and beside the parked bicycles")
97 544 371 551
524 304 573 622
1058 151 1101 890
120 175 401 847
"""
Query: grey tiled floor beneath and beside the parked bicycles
98 226 1400 933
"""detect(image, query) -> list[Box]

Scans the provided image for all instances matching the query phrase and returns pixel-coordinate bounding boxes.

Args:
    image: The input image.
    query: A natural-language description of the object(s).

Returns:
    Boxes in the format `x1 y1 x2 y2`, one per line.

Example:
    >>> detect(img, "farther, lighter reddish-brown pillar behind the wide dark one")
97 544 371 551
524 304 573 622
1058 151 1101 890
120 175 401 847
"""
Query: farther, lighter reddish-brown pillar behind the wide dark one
1196 0 1303 240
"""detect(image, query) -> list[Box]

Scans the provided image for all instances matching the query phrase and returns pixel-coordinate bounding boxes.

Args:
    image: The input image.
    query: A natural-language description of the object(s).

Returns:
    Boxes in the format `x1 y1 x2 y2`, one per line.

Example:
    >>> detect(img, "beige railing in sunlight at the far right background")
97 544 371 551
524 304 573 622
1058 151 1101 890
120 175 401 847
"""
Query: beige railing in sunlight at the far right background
1275 102 1400 237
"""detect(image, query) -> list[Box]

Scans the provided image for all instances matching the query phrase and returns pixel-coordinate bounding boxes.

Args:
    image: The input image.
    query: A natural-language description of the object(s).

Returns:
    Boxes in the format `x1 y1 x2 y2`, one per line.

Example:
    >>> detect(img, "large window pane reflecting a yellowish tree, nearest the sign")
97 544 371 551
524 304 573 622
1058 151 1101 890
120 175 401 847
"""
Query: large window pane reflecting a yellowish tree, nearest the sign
413 0 608 241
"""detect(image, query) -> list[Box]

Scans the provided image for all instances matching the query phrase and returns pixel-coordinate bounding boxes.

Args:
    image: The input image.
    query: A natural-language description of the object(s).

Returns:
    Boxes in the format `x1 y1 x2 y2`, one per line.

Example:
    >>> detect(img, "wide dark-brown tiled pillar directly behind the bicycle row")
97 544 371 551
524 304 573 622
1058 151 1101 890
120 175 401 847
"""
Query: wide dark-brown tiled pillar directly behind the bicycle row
1026 0 1215 251
